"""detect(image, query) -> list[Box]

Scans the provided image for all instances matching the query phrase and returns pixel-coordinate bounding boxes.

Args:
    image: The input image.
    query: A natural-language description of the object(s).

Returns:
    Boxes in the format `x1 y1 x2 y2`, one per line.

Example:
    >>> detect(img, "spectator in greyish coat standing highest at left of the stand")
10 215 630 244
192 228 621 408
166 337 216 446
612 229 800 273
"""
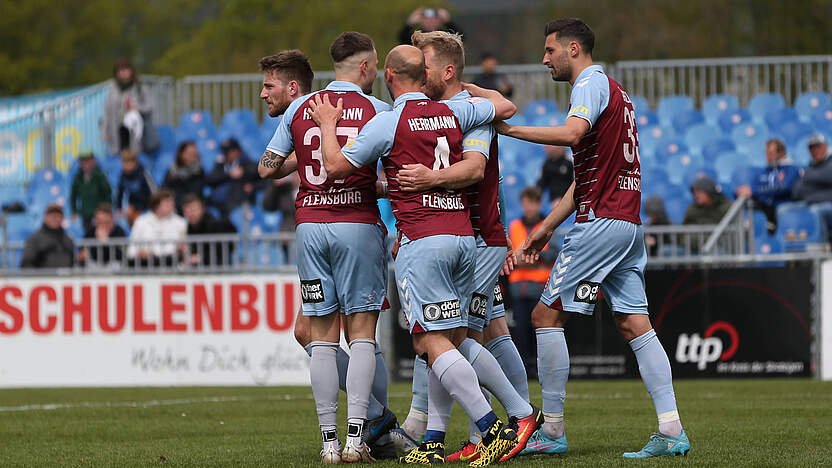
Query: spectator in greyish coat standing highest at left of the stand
101 59 160 154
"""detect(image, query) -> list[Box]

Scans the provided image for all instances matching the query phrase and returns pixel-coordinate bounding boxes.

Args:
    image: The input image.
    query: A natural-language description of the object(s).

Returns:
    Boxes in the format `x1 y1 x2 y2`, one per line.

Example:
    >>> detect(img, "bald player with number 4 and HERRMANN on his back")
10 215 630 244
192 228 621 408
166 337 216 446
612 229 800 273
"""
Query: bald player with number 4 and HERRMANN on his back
311 46 517 466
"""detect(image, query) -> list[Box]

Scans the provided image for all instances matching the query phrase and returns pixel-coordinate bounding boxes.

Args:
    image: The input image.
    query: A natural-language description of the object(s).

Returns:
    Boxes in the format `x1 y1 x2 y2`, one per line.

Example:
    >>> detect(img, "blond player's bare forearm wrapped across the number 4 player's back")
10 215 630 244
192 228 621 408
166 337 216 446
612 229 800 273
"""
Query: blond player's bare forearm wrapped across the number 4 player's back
399 151 486 192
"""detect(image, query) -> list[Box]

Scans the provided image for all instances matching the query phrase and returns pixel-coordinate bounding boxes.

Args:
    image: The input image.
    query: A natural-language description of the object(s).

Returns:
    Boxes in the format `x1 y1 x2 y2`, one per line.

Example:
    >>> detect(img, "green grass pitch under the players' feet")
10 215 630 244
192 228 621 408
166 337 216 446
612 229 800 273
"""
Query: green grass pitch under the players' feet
0 380 832 467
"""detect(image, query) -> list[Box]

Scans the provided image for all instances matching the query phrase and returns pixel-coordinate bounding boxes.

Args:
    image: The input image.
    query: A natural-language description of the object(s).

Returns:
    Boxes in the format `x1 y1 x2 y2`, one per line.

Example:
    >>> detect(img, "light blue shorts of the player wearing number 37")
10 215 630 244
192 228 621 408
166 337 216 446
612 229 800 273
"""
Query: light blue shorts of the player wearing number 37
297 223 387 316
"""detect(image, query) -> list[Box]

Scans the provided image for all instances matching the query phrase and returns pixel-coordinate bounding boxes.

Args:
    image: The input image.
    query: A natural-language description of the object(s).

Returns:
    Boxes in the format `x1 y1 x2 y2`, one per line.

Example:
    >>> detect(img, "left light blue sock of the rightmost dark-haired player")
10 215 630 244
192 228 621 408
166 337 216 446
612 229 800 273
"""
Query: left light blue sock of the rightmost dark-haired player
535 328 569 437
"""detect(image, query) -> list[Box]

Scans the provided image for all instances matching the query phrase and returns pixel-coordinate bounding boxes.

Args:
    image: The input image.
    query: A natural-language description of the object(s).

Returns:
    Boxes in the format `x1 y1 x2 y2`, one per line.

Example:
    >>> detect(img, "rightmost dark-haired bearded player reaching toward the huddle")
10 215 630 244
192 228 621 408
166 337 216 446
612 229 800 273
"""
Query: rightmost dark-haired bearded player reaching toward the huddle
488 19 690 458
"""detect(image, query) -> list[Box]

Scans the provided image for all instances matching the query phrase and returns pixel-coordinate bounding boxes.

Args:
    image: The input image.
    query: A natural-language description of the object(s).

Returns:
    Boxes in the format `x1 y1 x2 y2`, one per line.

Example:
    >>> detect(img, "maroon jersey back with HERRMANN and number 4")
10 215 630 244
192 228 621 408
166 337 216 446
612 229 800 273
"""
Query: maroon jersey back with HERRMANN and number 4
384 99 474 239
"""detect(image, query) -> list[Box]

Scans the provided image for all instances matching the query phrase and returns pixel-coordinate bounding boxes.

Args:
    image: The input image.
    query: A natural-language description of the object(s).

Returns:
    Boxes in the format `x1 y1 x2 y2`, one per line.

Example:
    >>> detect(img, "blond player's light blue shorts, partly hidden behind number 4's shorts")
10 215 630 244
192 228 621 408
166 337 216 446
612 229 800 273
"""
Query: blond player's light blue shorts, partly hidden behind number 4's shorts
468 236 506 332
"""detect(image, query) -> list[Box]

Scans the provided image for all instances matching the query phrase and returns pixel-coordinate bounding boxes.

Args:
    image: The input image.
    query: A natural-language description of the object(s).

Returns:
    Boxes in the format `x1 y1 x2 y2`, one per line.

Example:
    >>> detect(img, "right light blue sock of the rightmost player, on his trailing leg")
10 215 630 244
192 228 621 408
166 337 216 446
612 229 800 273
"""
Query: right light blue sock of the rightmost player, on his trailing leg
630 329 682 436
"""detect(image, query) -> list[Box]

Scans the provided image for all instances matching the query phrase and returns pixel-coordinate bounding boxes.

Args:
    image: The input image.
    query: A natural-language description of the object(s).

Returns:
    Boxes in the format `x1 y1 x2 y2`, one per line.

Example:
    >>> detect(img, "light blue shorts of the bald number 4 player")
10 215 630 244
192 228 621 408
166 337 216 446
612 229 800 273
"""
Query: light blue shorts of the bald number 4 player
396 235 477 333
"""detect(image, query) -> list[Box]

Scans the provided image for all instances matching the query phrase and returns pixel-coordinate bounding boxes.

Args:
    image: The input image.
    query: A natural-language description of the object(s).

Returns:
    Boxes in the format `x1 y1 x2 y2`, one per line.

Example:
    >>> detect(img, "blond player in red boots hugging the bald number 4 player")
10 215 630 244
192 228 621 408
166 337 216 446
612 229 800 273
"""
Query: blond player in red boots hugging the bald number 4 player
399 31 538 461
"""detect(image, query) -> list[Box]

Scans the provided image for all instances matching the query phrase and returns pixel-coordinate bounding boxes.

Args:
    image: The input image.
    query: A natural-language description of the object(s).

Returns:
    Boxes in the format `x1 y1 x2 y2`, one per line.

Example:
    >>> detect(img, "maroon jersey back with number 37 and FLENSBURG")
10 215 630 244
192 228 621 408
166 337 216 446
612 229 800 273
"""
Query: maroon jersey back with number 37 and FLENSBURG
290 90 379 224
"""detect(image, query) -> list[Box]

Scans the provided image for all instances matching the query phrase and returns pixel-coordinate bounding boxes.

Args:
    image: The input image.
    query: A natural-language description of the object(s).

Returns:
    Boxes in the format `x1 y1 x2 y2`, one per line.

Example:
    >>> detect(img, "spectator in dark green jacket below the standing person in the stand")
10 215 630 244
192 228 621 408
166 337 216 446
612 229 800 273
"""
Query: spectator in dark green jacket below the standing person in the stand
69 152 113 231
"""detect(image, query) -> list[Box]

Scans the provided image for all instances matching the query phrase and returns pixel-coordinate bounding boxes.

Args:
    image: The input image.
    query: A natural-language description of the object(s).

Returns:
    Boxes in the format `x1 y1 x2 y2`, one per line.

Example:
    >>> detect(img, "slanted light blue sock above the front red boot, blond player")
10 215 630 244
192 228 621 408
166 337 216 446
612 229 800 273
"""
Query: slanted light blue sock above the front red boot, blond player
459 338 532 418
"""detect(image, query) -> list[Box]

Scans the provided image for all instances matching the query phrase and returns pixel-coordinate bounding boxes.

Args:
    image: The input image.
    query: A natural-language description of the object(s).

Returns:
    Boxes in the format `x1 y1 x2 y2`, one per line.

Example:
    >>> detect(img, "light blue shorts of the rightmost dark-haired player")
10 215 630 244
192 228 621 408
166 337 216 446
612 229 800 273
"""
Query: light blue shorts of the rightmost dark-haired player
540 218 647 315
